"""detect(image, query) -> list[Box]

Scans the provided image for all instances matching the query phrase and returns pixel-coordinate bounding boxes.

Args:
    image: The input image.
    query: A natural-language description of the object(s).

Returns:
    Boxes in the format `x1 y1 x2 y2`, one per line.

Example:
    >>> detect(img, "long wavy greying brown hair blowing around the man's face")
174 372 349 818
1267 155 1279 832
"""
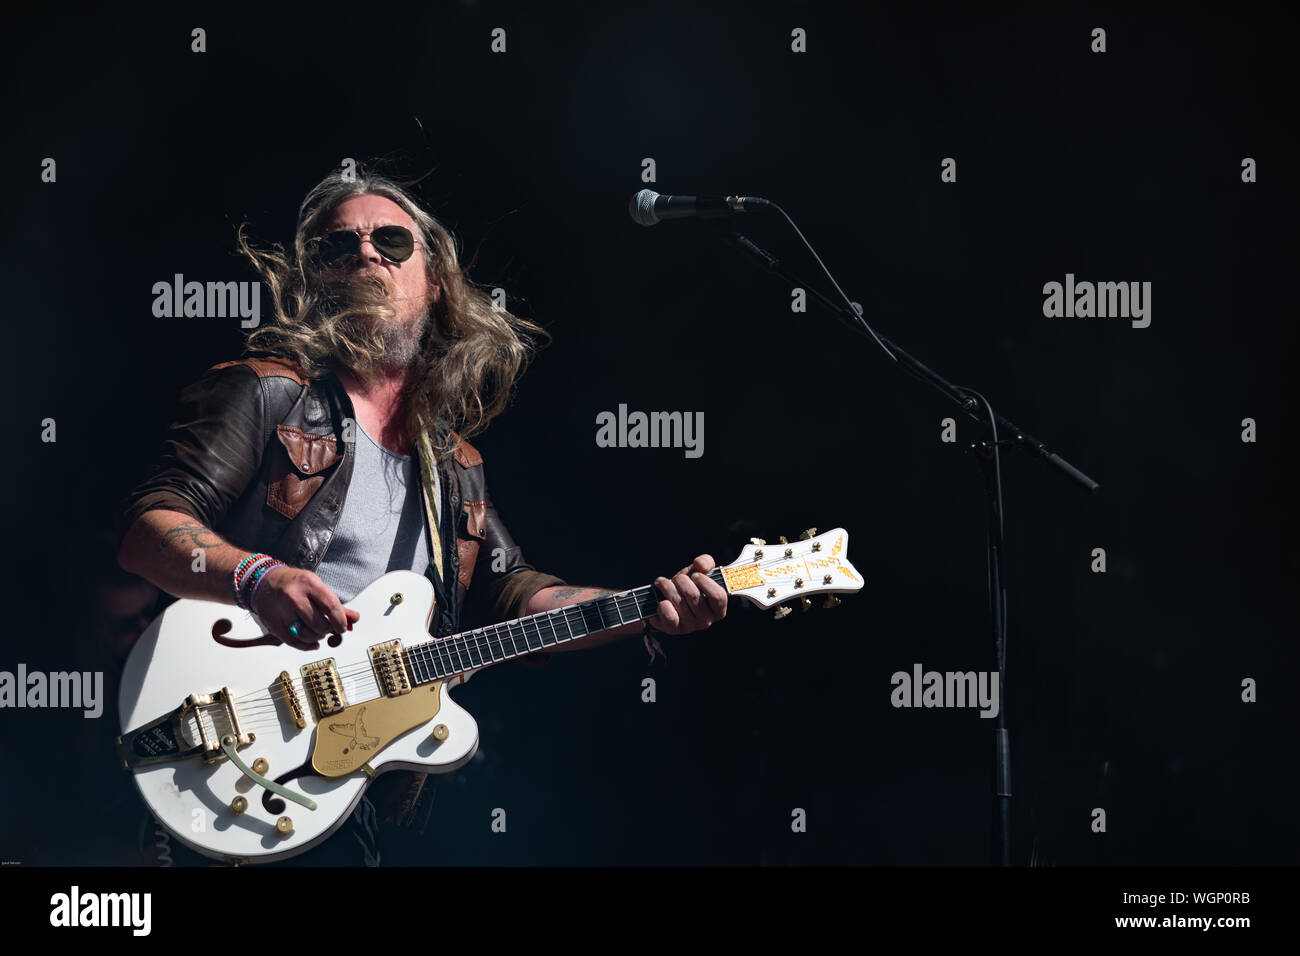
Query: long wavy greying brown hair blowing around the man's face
237 168 550 454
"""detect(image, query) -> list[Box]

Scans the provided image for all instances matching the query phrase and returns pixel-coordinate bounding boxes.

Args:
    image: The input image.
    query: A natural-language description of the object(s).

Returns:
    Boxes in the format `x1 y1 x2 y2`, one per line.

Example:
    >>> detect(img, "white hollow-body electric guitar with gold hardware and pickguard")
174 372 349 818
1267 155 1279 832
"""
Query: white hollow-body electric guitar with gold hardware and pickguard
117 528 862 864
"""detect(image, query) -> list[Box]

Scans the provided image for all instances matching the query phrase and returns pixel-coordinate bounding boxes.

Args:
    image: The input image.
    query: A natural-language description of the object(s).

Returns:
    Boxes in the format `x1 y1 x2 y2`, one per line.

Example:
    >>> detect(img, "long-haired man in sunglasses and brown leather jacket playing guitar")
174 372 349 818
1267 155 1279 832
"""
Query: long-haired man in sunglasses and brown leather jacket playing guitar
117 172 727 861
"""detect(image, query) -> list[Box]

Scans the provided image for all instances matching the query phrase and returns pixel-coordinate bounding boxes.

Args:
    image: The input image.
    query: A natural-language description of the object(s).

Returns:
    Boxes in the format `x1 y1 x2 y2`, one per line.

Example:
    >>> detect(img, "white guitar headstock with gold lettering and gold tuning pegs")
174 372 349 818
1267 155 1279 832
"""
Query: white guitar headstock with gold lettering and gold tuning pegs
722 528 863 619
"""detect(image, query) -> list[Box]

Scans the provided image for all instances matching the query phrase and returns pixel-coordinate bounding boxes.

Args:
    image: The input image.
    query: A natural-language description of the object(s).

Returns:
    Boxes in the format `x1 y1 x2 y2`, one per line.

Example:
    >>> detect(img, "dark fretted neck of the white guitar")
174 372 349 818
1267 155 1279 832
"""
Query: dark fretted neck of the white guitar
407 567 727 684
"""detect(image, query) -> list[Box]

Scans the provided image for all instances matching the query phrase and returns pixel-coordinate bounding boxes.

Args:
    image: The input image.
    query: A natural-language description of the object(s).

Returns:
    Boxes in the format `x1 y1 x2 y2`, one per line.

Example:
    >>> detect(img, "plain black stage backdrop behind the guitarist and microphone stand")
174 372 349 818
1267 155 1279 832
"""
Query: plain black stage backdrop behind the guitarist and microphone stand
0 3 1300 866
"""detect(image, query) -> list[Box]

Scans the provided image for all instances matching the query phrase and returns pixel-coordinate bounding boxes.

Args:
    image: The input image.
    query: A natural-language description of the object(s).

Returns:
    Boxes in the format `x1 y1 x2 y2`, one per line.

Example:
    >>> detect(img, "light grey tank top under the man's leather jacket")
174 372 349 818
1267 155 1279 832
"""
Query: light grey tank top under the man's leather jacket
316 423 437 604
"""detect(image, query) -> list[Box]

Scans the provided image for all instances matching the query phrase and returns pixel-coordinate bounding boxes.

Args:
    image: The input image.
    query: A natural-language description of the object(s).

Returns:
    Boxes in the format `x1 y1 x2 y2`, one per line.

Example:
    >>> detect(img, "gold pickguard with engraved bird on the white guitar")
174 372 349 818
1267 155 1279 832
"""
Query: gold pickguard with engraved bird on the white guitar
312 680 442 777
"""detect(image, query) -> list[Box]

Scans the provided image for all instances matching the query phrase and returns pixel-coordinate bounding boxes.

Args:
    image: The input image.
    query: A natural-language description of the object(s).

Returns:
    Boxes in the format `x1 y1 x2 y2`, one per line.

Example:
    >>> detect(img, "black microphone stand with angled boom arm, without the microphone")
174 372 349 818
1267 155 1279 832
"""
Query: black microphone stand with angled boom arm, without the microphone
723 232 1100 866
